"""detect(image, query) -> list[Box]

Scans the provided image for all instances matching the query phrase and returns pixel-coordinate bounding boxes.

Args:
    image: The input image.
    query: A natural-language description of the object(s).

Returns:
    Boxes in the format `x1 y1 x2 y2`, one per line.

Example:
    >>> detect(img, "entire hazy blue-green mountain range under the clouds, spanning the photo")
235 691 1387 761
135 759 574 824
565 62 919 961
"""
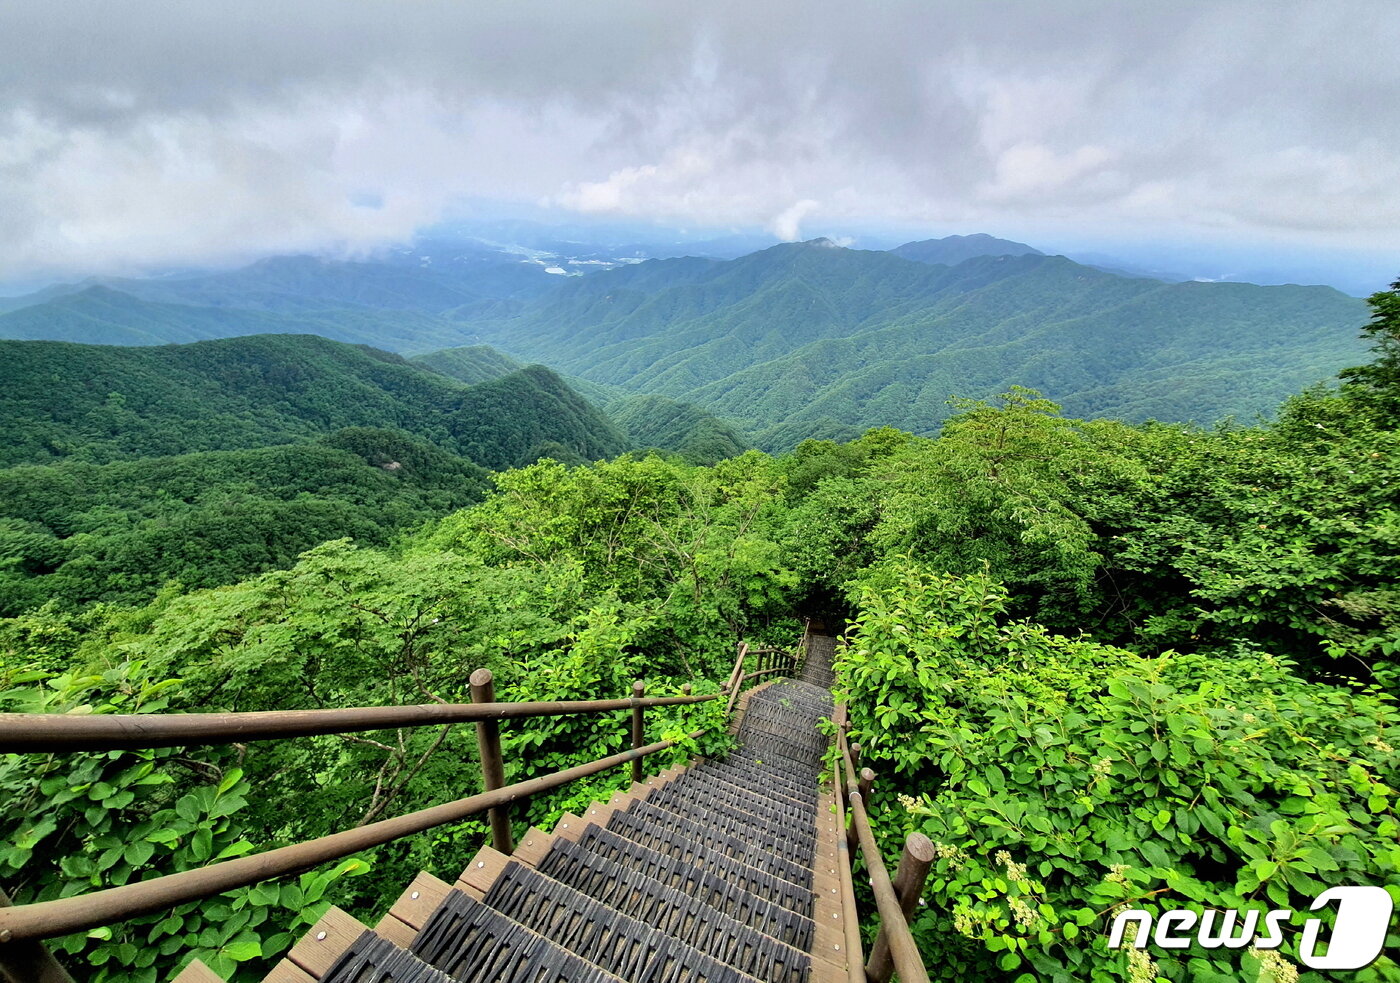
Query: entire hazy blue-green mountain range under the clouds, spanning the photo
0 235 1366 449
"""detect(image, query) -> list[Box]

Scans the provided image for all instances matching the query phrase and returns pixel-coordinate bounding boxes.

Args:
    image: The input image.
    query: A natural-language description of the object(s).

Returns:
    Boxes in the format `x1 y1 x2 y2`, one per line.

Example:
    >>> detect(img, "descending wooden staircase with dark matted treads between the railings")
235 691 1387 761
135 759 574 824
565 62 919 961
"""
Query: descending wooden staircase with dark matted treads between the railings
191 636 847 983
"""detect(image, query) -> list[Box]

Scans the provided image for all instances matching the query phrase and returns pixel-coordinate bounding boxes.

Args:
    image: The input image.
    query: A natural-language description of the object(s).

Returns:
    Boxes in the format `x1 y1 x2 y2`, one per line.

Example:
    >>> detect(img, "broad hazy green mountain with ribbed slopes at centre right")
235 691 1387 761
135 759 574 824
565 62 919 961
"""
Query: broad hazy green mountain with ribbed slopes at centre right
450 241 1364 448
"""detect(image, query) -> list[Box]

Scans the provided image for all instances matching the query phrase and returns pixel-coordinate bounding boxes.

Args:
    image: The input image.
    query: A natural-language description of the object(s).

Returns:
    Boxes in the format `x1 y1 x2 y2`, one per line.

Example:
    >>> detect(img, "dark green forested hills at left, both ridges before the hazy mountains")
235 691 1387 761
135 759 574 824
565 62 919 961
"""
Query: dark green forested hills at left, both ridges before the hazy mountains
0 335 749 616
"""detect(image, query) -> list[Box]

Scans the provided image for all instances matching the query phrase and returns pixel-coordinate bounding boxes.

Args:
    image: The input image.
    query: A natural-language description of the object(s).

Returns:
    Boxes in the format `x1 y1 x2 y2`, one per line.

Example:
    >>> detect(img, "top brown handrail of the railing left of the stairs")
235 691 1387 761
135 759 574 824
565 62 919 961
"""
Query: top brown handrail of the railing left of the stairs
0 693 722 753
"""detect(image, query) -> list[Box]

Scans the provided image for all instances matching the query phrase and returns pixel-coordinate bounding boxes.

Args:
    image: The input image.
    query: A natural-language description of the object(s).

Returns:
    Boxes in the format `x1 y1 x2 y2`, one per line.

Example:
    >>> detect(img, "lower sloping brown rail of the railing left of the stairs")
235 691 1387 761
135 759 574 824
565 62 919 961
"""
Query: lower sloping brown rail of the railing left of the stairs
0 730 706 961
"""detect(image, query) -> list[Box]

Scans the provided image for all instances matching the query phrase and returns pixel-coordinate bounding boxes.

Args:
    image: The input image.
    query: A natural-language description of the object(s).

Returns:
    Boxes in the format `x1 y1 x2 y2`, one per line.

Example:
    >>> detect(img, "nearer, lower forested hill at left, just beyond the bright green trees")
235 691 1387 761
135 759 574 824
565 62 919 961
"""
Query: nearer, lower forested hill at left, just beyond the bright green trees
0 427 486 615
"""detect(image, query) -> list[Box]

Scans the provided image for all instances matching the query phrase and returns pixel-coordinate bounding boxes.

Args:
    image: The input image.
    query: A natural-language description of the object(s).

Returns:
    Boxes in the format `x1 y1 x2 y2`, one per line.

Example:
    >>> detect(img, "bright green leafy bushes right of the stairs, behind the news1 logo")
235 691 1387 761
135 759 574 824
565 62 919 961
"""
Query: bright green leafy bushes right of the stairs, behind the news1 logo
837 562 1400 982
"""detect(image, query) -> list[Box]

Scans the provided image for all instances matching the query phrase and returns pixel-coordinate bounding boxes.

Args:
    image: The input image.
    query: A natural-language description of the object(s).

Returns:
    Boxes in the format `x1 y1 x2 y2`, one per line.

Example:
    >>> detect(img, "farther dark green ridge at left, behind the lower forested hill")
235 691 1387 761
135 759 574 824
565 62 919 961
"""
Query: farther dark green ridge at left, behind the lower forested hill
0 335 626 466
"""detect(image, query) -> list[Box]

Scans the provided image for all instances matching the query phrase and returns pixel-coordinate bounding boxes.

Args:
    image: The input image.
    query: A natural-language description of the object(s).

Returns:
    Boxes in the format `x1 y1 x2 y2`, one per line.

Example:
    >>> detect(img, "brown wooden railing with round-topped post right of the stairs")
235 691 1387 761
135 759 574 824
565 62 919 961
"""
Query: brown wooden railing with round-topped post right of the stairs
832 703 934 983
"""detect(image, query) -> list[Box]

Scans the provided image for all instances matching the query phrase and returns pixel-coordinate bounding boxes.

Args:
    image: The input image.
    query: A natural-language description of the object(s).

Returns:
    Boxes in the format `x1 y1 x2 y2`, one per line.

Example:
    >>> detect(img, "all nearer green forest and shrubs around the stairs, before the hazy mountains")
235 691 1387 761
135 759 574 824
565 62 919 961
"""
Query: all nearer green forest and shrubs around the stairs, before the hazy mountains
0 278 1400 983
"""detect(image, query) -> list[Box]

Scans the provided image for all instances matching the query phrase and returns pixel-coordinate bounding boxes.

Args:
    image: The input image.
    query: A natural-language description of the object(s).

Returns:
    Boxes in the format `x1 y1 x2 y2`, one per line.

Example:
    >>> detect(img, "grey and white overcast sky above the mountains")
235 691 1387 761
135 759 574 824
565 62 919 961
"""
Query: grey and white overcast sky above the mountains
0 0 1400 281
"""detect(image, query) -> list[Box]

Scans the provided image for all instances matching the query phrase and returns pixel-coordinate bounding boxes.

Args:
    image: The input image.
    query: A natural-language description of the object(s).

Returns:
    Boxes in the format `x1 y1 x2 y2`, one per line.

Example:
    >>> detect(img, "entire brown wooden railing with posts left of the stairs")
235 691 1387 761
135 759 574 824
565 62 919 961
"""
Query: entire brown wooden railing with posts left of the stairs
0 644 781 983
